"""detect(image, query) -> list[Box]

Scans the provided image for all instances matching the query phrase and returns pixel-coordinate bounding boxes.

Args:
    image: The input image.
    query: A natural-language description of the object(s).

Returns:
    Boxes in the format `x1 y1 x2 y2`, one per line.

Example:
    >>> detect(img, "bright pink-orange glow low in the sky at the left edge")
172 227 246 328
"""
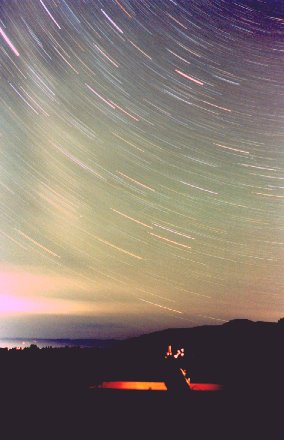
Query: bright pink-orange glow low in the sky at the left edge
0 267 122 316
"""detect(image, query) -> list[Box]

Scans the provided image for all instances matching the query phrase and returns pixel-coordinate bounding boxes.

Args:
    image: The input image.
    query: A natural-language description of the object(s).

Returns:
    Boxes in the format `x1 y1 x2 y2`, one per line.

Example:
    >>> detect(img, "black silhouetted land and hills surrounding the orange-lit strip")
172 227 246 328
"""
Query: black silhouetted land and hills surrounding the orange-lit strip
0 319 284 440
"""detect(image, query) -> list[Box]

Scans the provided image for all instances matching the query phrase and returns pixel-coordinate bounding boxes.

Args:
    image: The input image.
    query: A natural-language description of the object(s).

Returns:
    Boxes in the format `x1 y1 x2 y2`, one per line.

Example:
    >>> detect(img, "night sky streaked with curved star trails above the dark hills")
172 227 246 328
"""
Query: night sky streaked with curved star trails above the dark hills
0 0 284 338
